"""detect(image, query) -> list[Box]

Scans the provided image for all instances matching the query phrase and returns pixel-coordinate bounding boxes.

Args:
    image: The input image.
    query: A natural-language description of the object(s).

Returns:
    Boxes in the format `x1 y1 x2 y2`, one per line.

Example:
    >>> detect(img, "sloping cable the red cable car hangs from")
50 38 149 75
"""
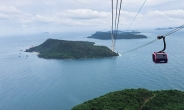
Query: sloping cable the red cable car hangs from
123 24 184 53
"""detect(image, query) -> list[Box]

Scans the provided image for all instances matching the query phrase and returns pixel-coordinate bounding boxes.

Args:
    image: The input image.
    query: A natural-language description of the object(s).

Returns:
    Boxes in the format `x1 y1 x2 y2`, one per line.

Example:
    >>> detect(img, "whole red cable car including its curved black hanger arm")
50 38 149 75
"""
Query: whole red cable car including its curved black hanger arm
152 36 168 63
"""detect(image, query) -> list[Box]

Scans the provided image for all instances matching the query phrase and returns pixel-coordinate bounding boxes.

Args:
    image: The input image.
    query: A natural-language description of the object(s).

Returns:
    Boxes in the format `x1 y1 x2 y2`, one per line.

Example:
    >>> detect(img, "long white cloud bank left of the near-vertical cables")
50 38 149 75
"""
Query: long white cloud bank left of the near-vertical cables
0 6 110 26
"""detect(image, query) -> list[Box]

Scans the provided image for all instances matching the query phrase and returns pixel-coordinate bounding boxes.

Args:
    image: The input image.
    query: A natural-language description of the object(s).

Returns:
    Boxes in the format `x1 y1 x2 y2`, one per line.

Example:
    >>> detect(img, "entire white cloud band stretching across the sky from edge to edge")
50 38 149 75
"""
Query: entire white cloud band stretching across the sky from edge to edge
0 6 184 26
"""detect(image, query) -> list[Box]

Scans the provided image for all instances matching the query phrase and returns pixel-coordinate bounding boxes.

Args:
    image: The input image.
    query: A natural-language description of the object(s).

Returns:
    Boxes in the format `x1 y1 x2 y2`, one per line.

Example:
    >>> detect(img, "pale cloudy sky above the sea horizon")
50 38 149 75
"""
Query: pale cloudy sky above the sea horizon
0 0 184 35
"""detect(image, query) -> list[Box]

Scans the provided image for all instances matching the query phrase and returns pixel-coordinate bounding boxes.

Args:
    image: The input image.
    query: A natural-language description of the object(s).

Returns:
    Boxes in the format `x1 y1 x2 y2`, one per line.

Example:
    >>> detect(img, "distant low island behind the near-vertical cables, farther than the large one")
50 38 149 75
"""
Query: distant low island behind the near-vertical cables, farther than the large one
87 30 147 40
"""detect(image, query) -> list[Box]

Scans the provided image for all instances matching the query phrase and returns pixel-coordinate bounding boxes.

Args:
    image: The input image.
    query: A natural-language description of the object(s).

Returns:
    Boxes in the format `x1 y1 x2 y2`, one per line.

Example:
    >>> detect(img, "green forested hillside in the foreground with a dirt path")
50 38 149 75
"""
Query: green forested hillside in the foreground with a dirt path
72 89 184 110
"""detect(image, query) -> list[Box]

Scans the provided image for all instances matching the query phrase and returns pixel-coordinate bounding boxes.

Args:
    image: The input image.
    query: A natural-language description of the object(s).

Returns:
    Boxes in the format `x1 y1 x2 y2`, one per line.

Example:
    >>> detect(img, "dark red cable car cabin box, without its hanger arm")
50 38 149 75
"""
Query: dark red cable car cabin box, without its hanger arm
153 52 168 63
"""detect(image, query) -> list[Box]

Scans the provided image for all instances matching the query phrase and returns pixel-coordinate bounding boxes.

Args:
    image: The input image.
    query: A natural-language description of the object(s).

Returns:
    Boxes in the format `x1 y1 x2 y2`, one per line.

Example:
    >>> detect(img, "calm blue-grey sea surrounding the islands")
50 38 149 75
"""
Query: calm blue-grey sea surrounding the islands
0 30 184 110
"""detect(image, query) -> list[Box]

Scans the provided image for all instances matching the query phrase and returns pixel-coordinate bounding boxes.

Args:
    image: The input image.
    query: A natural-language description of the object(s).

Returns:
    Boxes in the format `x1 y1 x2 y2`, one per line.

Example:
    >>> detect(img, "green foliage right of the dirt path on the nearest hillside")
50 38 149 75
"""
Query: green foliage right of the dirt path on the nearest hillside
142 90 184 110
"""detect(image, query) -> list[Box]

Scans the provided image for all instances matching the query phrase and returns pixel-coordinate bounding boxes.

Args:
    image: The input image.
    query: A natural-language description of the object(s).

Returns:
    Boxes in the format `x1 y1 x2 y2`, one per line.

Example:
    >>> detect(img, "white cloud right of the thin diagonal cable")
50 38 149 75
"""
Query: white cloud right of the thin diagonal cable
125 10 184 28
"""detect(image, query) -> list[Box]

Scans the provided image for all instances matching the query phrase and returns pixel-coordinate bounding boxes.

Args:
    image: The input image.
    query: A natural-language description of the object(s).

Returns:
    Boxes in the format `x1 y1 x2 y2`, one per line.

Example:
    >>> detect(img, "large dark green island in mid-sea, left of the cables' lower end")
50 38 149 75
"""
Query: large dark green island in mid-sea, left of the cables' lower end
25 39 118 59
